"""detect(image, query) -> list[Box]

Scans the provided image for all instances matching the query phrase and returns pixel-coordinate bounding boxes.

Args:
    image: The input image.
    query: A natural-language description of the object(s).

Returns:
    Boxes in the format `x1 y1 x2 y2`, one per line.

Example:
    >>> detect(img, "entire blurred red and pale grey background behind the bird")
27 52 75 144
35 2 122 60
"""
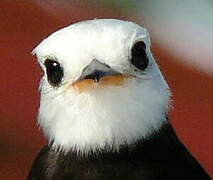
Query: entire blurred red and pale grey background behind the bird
0 0 213 180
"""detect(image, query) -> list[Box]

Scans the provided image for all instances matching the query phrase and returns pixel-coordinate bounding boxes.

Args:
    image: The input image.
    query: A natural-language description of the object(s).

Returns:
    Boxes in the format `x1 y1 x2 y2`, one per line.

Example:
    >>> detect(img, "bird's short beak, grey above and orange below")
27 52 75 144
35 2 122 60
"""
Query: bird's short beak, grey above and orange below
72 60 128 92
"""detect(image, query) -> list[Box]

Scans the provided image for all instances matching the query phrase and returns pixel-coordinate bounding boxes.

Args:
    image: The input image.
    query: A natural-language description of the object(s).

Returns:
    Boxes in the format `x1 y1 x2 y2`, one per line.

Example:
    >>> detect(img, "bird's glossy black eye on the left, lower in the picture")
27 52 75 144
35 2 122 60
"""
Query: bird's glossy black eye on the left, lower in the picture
44 59 64 86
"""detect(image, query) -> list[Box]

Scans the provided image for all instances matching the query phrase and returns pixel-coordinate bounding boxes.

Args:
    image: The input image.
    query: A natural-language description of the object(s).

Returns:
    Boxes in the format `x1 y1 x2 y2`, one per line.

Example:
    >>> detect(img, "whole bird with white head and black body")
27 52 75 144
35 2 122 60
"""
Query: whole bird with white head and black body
27 19 210 180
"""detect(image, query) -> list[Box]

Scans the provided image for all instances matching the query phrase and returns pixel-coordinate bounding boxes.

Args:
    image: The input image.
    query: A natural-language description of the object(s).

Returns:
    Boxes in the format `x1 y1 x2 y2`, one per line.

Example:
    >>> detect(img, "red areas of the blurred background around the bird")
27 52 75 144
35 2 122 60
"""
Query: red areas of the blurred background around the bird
0 0 213 180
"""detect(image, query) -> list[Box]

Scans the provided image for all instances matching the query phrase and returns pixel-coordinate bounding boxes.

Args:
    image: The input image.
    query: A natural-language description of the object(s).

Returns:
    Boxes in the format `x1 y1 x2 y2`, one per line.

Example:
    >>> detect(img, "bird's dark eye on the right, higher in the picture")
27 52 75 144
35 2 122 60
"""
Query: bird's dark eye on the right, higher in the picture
131 41 149 70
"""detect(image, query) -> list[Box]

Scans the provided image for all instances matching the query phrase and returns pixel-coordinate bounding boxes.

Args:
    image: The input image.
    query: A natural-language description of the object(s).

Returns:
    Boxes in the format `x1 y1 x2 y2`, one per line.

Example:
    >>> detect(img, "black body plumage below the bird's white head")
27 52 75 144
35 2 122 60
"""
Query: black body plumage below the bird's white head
28 123 210 180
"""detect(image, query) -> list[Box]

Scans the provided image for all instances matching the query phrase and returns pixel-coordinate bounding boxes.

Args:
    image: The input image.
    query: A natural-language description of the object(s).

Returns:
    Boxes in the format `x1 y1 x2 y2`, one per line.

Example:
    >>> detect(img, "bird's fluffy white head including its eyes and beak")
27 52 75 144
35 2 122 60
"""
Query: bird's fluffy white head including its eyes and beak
33 19 170 152
